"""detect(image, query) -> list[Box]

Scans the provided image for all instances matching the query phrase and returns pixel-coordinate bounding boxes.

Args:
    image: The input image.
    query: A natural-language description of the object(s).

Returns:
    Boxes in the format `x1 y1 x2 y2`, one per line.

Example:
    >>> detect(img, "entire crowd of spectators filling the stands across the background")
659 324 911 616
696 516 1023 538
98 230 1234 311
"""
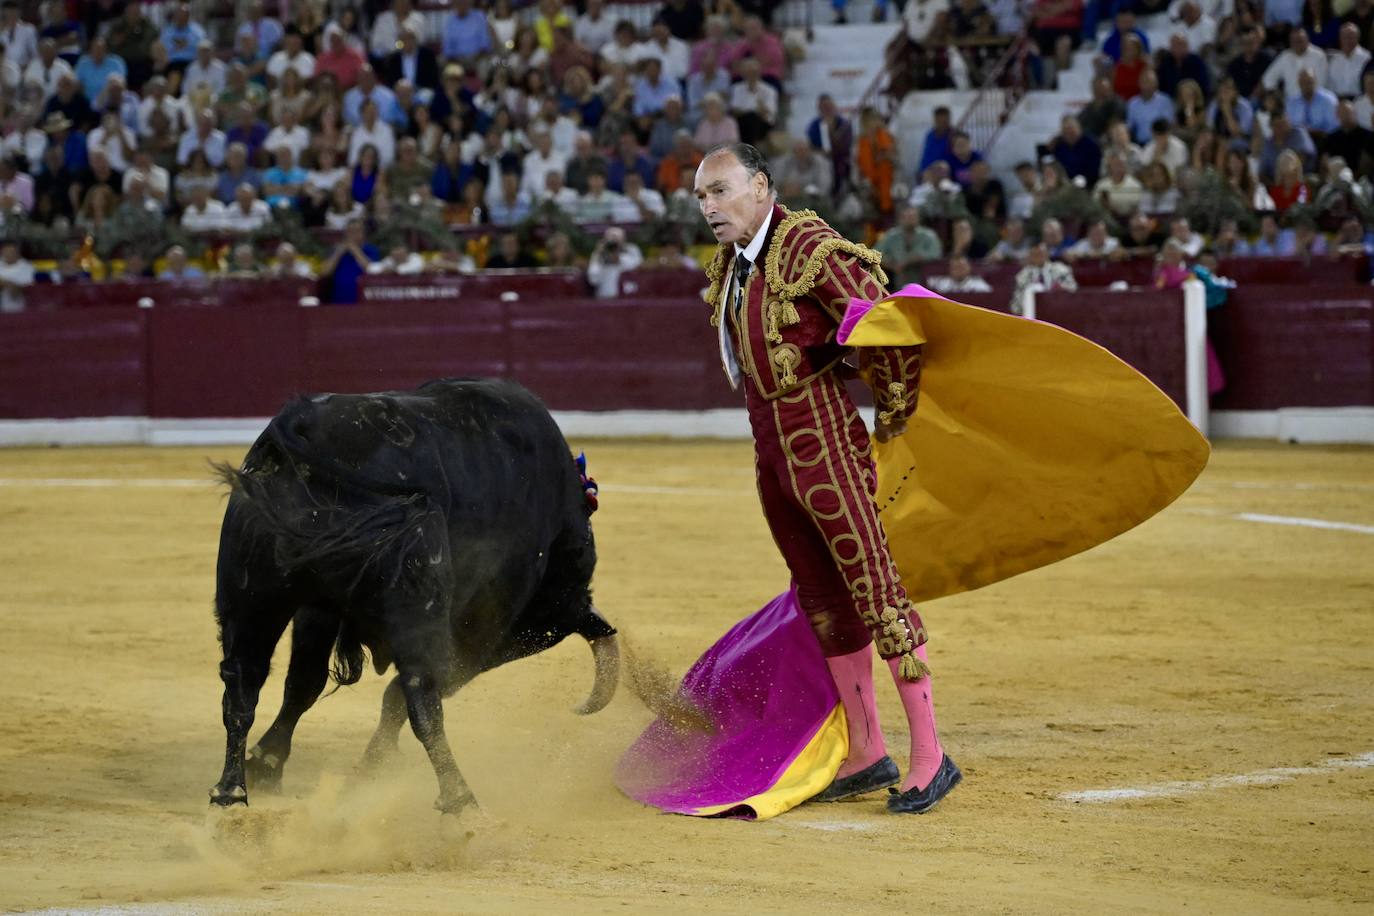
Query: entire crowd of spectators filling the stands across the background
0 0 1374 309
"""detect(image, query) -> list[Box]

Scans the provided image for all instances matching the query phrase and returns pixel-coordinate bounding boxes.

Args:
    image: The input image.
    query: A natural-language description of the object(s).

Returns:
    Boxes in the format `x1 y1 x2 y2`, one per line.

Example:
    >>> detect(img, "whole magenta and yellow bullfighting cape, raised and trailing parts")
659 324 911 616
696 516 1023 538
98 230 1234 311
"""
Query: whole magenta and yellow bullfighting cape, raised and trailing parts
617 284 1210 817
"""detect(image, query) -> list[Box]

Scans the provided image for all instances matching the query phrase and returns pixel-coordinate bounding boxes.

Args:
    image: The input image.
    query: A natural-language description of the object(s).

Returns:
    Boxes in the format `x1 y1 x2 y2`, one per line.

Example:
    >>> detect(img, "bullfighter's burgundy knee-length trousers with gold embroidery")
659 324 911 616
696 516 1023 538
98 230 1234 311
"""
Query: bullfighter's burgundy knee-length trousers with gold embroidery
745 372 926 659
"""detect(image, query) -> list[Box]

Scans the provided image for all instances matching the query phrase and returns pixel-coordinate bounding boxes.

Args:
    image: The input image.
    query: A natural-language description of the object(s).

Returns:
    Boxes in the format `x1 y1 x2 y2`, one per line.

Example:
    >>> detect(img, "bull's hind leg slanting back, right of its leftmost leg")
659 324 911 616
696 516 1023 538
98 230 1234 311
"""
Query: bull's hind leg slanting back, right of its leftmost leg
246 607 339 792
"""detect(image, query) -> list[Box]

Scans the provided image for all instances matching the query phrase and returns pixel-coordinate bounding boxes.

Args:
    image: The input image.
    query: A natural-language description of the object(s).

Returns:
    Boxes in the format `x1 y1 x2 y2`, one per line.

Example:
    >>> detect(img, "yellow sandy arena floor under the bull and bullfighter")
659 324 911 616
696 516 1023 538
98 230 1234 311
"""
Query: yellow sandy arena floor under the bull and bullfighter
0 442 1374 916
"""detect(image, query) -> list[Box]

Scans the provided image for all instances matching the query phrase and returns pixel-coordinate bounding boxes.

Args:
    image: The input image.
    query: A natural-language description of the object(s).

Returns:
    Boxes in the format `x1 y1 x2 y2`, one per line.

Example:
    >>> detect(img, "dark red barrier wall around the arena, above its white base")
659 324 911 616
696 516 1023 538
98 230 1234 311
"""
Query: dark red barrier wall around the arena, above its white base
0 286 1374 419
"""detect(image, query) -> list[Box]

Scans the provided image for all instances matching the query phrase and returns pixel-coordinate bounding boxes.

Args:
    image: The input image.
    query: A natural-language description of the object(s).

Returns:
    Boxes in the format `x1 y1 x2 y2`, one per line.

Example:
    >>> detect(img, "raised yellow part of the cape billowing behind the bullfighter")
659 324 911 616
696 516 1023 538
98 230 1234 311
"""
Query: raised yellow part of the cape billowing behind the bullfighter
841 287 1210 602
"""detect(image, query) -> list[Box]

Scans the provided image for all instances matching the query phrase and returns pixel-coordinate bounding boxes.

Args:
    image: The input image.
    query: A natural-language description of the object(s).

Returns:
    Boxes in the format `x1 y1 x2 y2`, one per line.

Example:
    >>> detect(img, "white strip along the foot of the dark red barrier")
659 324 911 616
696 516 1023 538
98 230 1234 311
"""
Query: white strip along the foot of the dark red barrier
0 407 1374 446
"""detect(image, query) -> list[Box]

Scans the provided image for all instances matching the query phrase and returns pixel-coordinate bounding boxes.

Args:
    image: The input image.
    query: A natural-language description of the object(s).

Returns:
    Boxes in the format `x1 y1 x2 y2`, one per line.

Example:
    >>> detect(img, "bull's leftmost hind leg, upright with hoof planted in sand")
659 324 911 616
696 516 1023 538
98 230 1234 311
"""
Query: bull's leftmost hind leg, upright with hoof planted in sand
210 606 291 806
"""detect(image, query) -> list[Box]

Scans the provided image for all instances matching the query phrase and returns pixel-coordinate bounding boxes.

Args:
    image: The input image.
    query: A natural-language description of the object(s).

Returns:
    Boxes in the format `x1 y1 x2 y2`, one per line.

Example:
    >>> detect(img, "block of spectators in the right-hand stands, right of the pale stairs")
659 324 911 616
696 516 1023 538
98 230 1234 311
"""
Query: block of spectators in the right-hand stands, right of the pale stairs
878 0 1374 310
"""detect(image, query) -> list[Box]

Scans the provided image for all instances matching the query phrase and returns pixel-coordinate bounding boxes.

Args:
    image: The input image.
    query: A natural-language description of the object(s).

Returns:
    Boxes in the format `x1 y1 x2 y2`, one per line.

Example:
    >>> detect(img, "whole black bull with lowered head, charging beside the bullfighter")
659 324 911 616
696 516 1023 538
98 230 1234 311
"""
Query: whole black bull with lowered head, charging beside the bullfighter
210 379 618 812
